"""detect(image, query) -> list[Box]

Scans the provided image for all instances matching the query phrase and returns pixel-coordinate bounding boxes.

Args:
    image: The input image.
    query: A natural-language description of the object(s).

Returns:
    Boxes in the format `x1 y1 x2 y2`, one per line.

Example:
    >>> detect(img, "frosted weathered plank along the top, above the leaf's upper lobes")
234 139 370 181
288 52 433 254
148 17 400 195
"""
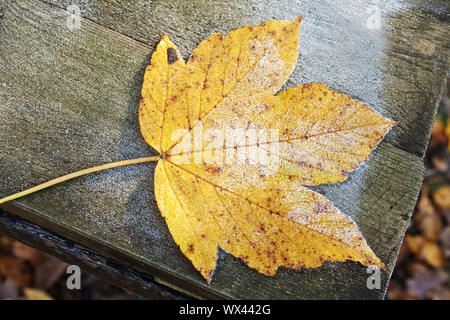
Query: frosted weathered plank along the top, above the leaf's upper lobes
46 0 450 157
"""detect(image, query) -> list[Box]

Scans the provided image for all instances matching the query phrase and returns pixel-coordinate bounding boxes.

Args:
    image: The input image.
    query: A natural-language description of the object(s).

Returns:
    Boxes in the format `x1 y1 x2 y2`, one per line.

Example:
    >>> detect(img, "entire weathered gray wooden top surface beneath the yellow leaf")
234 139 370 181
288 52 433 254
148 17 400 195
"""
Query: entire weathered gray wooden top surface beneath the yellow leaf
0 0 450 299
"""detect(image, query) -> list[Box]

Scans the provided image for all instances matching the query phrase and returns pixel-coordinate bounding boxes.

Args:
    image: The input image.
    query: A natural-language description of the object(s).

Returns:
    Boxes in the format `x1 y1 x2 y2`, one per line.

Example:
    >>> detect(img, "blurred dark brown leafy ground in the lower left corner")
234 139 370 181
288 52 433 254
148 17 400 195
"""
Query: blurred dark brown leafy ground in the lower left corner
0 235 136 300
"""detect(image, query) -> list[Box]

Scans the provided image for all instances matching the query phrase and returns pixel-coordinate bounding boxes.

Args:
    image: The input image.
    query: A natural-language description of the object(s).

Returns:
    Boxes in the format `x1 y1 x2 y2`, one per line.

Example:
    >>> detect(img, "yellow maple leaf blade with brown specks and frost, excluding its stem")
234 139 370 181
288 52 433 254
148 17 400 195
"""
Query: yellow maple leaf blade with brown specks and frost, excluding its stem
139 17 395 282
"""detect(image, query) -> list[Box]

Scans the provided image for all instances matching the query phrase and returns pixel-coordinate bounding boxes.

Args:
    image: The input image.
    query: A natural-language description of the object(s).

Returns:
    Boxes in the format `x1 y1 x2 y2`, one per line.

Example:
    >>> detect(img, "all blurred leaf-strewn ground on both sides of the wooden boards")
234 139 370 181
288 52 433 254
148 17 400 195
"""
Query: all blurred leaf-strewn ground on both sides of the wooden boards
0 81 450 300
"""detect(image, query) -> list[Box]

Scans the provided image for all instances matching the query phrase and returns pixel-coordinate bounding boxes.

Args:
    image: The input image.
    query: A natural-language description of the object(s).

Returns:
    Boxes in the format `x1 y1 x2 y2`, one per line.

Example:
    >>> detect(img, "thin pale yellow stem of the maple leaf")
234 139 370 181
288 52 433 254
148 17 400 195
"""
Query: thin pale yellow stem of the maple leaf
0 155 161 204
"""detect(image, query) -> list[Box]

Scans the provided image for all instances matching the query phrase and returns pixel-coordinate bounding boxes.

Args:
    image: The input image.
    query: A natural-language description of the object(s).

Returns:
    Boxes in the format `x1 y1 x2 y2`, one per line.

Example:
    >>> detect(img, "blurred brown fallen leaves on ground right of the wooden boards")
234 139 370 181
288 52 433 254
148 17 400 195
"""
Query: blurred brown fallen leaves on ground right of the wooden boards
387 79 450 300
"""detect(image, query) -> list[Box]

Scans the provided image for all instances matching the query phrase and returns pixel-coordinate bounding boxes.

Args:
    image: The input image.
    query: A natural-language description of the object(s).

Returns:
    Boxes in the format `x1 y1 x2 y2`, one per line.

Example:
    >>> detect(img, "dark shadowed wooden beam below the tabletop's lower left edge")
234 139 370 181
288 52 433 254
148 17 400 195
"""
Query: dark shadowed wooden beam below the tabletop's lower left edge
0 210 190 300
